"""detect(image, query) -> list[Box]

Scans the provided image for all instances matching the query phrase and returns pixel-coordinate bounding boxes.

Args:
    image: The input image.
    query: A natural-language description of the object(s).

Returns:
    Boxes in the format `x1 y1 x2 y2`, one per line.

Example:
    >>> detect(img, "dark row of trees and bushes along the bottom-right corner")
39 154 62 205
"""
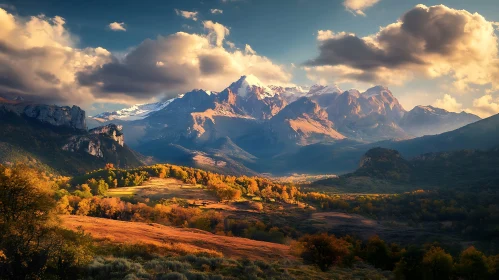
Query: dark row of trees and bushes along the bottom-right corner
291 233 499 280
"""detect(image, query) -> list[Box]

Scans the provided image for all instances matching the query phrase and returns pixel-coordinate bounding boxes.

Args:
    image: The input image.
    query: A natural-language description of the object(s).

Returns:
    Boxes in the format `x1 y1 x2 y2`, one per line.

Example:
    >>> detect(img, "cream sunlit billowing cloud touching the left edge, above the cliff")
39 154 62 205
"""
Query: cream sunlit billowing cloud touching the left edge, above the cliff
0 8 110 104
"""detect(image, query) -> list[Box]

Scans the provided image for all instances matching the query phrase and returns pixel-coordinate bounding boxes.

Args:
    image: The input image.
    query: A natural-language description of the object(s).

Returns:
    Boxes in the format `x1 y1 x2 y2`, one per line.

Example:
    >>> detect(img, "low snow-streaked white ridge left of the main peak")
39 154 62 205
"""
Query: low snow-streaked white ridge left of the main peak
91 98 176 121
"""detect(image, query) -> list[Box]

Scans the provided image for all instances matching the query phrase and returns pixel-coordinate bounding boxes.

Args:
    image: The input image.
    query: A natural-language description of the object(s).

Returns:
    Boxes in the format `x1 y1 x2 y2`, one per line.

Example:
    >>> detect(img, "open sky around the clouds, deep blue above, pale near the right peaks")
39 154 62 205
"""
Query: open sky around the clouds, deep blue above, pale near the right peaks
0 0 499 115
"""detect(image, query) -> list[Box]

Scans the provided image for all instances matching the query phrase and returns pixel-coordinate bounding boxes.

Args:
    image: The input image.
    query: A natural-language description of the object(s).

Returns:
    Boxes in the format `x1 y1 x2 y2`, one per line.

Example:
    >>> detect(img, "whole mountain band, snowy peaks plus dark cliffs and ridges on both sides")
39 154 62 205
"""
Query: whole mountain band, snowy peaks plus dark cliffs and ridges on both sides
0 75 486 175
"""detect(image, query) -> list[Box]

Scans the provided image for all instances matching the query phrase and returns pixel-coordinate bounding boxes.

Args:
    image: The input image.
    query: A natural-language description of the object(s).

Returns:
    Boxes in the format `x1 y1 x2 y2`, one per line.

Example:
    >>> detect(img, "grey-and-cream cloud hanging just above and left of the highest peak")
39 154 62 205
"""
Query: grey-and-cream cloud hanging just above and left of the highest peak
79 32 291 100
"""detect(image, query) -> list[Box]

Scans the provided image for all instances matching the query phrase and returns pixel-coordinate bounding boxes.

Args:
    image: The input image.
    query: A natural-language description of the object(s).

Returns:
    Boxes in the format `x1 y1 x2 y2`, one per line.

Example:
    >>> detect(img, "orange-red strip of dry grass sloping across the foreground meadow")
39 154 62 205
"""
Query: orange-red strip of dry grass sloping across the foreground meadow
61 216 295 260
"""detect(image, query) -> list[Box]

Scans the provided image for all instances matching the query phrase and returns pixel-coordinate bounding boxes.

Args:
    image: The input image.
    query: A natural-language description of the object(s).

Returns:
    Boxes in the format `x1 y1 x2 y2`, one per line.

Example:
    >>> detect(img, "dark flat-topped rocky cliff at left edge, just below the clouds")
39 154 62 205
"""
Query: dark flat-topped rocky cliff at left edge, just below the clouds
0 101 87 130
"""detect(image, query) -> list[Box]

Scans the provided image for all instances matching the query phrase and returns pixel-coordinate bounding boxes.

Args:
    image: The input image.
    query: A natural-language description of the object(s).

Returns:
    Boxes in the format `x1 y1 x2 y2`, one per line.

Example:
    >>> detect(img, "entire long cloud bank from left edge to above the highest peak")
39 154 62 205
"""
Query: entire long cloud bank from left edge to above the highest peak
0 9 291 106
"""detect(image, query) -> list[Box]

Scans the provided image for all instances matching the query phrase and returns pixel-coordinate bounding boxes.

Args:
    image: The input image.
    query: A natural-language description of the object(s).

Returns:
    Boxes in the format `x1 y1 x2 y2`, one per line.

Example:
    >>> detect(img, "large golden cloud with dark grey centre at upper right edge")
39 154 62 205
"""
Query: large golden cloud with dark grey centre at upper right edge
305 5 499 91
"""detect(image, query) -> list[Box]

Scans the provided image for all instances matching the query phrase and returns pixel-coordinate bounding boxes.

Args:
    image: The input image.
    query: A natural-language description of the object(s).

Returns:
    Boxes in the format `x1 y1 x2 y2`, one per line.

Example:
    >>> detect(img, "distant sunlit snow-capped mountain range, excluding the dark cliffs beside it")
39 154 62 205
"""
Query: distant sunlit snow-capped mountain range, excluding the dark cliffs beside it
89 75 480 174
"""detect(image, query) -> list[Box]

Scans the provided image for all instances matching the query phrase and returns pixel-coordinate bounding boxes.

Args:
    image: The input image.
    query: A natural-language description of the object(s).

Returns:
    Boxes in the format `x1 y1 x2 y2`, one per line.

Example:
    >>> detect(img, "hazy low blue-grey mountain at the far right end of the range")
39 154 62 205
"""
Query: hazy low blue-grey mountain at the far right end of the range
399 106 481 136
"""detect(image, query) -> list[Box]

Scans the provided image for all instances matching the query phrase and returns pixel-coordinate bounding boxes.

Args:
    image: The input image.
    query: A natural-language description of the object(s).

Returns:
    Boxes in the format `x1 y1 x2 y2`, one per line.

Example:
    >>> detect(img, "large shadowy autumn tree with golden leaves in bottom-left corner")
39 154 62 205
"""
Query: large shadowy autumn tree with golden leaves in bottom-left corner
0 165 94 279
